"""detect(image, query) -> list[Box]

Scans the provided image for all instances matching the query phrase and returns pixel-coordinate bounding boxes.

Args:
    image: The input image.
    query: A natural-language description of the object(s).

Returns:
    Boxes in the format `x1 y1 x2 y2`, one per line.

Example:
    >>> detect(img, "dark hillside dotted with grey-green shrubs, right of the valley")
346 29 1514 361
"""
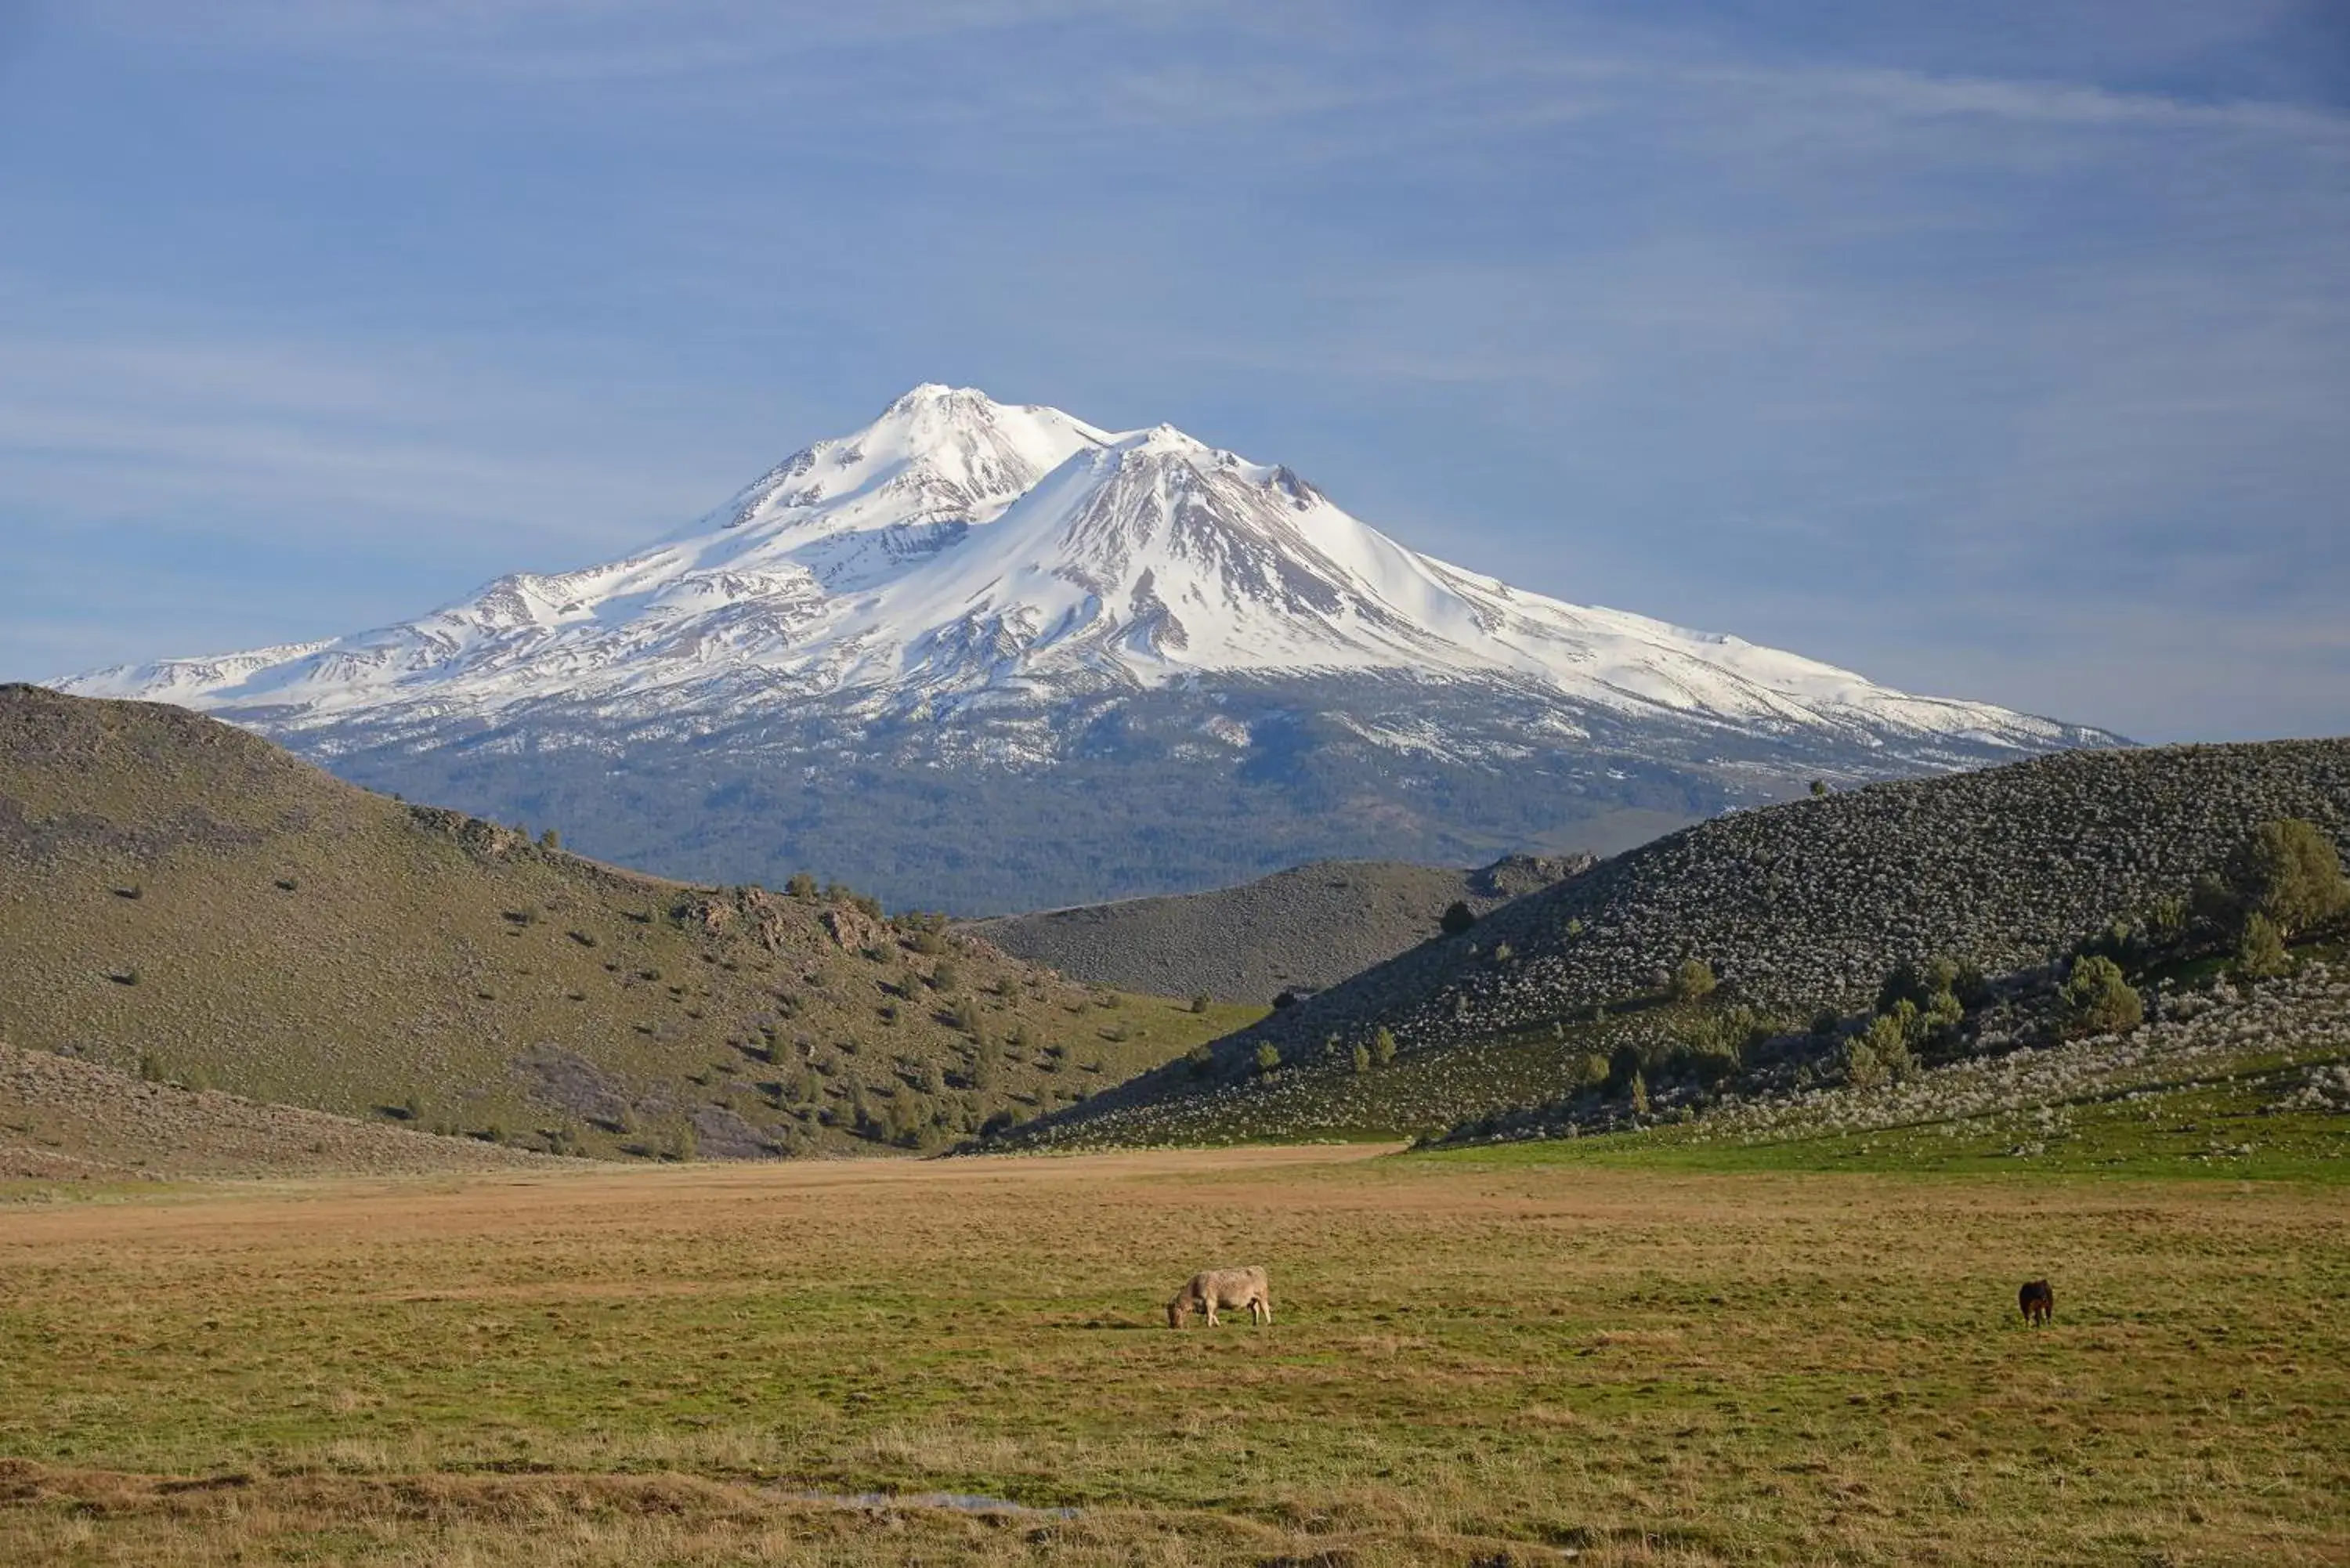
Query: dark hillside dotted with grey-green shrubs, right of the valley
1020 740 2350 1145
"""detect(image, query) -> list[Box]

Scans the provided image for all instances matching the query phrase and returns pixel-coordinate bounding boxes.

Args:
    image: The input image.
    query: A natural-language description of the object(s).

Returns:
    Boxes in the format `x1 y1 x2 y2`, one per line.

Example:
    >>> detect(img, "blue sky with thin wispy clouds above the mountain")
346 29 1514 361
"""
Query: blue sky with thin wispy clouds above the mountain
0 0 2350 740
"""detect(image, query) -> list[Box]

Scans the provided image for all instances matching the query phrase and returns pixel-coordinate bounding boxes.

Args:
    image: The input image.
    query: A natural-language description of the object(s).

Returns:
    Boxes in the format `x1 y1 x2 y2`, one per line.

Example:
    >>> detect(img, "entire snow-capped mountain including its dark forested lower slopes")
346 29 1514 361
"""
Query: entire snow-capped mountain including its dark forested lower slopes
59 385 2115 912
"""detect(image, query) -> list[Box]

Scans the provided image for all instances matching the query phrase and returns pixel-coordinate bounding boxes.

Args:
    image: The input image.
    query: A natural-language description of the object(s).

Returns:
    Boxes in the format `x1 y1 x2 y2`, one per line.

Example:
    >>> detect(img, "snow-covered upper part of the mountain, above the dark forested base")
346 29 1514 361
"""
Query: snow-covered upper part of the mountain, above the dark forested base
66 385 2075 750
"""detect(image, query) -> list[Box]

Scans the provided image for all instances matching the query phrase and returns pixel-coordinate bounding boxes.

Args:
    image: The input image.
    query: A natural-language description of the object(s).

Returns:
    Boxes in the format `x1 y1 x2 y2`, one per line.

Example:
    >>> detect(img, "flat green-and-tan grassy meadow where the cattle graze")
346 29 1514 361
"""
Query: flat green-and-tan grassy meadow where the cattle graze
0 1140 2350 1566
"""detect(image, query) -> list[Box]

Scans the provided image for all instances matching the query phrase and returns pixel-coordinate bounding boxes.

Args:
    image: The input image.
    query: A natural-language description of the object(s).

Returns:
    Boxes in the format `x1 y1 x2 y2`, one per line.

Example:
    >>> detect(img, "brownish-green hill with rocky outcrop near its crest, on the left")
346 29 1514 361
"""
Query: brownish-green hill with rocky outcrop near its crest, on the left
0 686 1253 1157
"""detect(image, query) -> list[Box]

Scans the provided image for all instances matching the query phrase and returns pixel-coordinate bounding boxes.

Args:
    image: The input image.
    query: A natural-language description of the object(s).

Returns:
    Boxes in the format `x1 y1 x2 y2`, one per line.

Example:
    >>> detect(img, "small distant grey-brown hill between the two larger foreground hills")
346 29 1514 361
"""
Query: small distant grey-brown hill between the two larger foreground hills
968 856 1591 1002
